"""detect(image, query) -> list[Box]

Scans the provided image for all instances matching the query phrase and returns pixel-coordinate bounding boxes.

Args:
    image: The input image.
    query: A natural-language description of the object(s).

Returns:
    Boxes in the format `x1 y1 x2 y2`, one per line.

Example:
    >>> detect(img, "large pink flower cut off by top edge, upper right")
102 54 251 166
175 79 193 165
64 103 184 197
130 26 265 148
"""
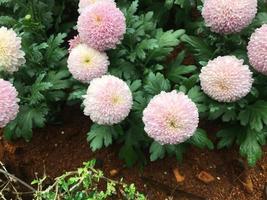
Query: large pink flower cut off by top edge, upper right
202 0 257 34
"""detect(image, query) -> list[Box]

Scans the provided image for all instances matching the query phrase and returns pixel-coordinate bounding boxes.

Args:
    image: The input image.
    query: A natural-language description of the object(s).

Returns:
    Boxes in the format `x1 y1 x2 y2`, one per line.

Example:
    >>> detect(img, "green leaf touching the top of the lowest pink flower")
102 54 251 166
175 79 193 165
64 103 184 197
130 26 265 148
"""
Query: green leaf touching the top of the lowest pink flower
144 72 171 95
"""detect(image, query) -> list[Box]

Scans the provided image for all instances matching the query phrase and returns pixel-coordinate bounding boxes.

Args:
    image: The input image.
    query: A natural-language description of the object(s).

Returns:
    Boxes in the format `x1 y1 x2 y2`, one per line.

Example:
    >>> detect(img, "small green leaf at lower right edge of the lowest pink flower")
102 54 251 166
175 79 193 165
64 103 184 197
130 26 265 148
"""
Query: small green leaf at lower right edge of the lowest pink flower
189 129 214 150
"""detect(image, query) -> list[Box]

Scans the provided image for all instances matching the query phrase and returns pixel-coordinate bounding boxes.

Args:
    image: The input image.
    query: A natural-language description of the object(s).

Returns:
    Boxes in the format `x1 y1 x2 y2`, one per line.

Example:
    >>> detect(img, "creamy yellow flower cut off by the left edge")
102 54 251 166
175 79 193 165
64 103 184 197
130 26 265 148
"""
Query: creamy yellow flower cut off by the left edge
0 27 25 73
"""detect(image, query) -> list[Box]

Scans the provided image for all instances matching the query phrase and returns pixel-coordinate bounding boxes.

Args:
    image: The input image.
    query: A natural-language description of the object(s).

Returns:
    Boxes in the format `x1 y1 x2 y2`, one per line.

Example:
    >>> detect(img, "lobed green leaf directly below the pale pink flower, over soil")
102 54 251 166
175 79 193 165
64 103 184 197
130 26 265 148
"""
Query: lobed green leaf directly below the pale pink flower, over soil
87 124 113 151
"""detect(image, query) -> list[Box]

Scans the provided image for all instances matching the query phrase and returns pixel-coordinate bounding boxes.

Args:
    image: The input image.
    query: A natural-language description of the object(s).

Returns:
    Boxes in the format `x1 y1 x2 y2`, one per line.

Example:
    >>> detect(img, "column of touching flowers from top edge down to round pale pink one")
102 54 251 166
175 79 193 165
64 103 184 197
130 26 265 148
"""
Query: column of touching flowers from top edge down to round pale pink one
68 0 129 125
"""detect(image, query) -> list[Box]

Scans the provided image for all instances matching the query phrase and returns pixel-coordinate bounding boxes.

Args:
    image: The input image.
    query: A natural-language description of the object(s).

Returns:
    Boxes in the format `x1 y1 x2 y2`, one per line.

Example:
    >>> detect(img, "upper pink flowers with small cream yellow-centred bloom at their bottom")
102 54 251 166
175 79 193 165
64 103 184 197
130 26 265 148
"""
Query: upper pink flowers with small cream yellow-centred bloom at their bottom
68 0 126 83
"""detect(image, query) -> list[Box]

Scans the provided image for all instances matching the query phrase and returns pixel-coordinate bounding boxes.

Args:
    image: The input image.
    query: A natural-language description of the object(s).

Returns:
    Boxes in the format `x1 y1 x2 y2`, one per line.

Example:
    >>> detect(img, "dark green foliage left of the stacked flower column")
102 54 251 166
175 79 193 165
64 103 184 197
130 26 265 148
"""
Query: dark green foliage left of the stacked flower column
0 0 74 141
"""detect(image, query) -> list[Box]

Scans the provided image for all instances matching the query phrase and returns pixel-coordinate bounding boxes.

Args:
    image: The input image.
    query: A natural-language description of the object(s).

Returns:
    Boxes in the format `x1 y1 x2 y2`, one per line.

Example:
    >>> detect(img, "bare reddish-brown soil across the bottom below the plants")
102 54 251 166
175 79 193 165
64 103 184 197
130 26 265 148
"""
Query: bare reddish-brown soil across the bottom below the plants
0 105 267 200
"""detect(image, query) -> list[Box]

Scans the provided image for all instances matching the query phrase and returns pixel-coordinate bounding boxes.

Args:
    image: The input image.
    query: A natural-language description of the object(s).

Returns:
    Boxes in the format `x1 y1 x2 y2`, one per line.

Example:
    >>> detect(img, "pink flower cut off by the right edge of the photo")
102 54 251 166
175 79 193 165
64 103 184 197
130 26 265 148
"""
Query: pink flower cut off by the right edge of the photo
247 24 267 75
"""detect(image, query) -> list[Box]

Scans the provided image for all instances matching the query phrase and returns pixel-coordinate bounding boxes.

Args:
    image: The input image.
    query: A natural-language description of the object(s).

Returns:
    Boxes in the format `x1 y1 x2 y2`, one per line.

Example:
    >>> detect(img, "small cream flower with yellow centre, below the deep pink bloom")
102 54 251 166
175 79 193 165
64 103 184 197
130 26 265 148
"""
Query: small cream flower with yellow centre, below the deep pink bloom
68 44 109 83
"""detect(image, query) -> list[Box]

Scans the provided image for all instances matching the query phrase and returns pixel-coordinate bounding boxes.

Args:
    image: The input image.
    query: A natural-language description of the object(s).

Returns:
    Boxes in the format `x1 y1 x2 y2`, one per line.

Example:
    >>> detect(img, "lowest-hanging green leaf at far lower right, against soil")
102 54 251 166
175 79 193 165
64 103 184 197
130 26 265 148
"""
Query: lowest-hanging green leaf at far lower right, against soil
240 129 262 167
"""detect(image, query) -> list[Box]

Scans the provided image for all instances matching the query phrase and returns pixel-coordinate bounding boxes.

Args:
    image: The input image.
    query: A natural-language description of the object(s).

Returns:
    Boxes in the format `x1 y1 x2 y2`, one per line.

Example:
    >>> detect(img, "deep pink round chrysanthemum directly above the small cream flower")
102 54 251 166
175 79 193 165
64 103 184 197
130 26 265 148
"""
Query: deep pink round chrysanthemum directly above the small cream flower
78 2 126 51
